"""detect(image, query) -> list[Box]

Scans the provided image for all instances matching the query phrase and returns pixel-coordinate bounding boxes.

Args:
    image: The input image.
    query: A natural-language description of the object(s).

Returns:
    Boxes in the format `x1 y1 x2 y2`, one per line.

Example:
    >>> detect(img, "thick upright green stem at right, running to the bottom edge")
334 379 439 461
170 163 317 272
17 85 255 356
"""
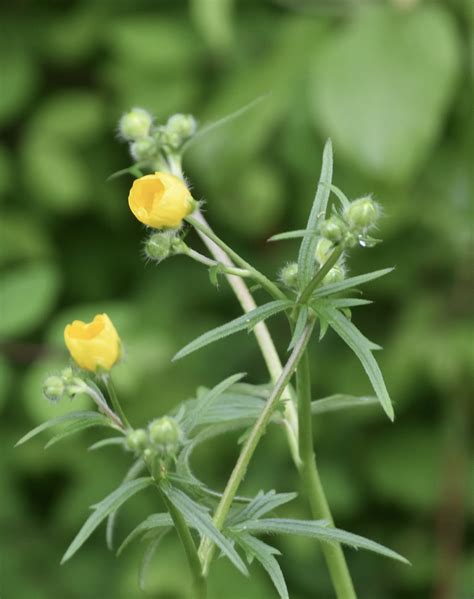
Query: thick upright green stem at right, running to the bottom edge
296 351 356 599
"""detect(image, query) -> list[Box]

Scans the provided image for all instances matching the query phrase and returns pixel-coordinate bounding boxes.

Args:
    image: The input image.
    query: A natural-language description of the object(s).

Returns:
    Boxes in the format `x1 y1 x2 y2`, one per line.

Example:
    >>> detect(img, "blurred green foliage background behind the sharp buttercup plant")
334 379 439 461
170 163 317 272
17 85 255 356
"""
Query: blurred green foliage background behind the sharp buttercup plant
0 0 474 599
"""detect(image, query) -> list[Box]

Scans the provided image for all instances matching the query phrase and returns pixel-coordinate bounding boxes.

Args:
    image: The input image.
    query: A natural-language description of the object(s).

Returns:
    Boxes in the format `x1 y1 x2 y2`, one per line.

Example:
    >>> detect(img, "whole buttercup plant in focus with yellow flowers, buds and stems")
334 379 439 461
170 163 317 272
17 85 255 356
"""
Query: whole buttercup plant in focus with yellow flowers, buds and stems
18 108 407 599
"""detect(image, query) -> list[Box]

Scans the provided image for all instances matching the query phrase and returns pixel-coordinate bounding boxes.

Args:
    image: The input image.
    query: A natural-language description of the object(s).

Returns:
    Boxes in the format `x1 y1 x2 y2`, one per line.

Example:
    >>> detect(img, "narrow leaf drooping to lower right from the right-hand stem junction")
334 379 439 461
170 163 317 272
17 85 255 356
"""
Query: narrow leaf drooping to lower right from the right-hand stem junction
315 304 394 421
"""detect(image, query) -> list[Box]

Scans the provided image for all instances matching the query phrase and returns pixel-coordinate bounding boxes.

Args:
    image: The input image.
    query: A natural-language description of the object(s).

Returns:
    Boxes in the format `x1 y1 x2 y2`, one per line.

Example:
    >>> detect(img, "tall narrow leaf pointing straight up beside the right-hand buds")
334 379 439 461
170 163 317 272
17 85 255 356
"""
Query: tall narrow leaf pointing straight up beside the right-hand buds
298 139 332 289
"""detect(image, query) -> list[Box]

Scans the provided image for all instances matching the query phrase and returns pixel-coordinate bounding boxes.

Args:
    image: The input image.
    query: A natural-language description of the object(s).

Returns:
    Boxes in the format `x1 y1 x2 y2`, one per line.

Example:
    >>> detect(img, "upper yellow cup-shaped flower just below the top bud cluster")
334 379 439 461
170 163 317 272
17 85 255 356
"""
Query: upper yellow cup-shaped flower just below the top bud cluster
128 173 196 229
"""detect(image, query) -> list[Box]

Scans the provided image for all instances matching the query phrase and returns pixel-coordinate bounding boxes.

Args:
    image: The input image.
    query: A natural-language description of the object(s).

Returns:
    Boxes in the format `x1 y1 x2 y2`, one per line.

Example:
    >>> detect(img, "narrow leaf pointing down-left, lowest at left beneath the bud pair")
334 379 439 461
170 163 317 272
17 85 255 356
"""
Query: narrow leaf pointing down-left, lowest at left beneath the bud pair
61 477 153 564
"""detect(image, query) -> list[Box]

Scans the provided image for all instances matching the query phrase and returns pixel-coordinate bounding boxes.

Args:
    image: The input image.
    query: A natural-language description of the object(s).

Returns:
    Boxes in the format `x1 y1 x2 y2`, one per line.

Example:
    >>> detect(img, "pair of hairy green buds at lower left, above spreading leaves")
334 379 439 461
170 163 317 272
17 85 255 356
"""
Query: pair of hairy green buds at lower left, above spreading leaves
126 416 183 461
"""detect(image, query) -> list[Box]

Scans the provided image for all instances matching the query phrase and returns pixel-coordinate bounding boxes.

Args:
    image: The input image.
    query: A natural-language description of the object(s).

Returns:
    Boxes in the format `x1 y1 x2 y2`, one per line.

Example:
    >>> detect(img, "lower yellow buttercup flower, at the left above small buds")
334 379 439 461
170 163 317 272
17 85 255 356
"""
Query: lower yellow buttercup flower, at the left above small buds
64 314 120 372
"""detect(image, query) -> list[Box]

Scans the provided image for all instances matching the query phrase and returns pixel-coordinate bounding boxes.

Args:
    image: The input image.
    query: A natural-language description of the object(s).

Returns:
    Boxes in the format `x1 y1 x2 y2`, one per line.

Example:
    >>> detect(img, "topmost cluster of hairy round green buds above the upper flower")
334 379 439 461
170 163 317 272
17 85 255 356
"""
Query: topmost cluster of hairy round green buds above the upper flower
118 108 197 169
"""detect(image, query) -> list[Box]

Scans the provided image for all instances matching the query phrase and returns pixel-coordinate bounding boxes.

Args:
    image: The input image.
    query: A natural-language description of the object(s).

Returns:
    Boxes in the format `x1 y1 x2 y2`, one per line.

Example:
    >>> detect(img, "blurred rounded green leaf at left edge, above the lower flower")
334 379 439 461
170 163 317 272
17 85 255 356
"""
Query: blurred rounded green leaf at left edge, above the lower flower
0 262 60 340
